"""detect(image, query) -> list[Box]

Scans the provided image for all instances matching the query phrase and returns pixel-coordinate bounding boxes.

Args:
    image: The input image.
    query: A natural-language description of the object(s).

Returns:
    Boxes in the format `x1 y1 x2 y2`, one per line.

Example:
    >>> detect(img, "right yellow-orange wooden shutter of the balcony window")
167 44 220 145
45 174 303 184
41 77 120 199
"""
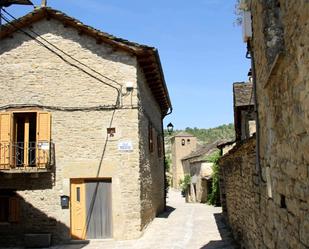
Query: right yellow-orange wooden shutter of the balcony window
36 112 51 168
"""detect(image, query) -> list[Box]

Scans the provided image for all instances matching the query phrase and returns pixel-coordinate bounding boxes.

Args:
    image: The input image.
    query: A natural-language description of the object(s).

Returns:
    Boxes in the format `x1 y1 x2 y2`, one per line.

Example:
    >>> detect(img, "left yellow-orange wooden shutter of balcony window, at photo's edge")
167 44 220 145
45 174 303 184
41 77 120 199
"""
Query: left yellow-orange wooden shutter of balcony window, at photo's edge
0 112 12 169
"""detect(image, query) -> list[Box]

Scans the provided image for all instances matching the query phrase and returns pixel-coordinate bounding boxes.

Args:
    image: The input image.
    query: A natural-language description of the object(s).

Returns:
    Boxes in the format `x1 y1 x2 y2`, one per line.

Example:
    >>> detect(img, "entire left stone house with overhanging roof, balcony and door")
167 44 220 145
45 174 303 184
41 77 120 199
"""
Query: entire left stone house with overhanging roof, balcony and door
0 8 171 246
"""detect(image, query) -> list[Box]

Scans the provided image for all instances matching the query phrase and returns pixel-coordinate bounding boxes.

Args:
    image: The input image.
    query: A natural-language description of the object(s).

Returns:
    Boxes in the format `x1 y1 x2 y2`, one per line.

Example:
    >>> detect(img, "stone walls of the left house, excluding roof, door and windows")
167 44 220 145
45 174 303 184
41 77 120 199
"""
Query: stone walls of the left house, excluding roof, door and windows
0 8 171 245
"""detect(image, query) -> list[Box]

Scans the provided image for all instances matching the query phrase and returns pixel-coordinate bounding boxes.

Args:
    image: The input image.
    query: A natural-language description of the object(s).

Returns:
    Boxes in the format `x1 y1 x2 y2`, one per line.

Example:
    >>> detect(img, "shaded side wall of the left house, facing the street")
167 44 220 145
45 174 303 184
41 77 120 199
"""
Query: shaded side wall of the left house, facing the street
138 64 165 229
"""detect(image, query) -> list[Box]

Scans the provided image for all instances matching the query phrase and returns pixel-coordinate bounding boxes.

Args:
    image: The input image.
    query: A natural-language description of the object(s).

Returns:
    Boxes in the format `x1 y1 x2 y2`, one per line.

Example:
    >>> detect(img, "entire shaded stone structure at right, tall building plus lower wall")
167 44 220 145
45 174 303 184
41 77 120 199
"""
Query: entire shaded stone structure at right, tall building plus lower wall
220 0 309 249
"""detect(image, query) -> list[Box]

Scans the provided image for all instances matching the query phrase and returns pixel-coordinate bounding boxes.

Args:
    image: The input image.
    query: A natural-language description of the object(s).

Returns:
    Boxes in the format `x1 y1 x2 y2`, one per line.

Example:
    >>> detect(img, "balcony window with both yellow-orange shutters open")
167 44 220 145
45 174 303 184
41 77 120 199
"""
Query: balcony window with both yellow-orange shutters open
0 111 51 169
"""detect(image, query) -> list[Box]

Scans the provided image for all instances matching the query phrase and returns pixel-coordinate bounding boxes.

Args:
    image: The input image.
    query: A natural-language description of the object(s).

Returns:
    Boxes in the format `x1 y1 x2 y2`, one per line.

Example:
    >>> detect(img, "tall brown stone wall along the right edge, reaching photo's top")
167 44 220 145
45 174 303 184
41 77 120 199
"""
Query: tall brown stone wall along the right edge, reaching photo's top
251 0 309 248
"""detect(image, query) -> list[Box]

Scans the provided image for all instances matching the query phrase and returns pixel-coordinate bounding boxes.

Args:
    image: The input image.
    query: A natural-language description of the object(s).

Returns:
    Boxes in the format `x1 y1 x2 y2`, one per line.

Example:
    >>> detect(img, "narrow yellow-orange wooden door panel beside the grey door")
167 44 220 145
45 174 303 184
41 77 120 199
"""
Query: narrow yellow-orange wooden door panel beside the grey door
71 179 86 239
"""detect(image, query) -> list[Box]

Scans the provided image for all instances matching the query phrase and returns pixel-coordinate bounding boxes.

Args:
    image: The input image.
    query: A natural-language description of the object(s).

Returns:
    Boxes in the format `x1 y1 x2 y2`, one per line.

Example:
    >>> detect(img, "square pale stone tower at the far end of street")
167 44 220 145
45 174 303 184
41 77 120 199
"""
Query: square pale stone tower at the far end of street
171 132 197 188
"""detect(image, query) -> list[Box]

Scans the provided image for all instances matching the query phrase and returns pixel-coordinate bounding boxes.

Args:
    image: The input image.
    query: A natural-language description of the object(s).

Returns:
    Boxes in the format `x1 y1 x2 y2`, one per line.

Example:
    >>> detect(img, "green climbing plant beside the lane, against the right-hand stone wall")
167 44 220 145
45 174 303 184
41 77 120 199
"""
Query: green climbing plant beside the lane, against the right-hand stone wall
207 152 220 206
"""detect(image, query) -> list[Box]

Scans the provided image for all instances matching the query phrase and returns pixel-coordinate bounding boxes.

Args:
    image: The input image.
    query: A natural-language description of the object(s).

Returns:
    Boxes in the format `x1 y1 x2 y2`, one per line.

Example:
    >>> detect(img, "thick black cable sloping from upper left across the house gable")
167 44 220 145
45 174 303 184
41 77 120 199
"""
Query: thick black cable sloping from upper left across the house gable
1 12 121 107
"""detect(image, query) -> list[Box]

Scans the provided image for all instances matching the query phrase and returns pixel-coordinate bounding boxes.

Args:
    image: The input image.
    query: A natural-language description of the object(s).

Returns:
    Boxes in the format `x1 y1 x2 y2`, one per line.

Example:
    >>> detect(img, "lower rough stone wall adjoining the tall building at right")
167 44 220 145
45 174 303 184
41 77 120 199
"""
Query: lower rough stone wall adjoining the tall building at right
219 138 265 249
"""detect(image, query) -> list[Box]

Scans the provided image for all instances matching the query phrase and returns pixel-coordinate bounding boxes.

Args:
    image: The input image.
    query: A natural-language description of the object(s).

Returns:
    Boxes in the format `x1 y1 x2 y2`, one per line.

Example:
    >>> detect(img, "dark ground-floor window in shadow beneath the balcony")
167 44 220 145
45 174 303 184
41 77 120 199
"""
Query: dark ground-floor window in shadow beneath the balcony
0 190 20 223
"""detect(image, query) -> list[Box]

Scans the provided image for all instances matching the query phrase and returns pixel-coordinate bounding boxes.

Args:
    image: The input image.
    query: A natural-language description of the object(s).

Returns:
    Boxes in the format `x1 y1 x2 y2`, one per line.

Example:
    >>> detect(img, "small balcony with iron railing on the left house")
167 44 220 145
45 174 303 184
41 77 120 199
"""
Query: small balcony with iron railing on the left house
0 142 55 173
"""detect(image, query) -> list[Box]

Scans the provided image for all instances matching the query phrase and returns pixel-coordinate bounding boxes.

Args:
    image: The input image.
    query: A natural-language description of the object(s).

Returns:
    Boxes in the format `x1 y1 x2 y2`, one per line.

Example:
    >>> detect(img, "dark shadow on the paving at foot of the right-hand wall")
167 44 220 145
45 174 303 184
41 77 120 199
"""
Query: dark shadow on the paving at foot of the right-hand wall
200 213 239 249
